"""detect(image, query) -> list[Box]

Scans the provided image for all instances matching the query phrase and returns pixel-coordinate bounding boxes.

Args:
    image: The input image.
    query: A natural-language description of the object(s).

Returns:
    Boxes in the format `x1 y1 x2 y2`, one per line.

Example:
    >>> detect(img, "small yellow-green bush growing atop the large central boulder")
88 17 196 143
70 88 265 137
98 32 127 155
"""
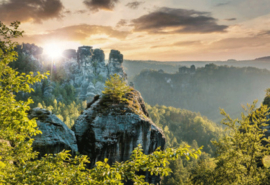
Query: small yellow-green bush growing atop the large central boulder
102 74 131 103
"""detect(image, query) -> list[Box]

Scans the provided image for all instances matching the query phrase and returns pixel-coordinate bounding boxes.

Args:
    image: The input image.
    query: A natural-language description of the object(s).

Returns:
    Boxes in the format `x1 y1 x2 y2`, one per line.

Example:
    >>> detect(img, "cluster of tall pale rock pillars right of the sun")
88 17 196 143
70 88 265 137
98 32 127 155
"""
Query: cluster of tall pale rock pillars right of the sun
57 46 127 101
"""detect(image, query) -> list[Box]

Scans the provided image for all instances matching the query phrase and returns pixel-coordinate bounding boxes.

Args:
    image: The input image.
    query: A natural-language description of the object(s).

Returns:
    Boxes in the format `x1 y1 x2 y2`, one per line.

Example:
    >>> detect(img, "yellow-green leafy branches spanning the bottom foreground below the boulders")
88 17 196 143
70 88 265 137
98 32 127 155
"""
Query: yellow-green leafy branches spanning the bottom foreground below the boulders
0 146 200 185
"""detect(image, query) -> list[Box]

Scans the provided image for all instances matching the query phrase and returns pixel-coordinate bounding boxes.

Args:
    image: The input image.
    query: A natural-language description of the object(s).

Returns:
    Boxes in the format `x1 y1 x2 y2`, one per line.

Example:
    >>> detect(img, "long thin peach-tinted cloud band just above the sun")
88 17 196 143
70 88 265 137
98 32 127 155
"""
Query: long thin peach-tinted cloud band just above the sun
19 24 129 43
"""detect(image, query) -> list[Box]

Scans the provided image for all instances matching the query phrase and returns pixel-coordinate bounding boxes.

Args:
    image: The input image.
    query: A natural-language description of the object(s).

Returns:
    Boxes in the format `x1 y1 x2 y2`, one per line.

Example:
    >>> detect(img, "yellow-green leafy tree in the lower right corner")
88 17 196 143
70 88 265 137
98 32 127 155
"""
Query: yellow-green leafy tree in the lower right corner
193 102 270 184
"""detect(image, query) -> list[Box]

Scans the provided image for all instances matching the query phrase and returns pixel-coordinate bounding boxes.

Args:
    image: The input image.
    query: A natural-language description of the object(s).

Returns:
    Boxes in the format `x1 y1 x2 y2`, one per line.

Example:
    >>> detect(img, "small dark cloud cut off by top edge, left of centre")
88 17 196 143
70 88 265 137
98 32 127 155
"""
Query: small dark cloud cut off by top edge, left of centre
83 0 119 12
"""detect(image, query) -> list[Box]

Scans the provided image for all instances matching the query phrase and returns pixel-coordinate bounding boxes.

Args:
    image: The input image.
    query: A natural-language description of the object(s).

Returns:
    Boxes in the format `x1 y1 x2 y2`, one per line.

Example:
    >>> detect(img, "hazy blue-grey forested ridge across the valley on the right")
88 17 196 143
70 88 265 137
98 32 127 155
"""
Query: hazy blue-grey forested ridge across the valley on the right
133 64 270 122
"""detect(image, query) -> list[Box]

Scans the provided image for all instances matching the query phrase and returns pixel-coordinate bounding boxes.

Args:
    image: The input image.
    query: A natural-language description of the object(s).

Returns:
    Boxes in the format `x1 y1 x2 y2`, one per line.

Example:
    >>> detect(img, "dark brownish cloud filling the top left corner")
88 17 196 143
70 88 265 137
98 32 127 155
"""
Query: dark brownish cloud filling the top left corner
0 0 64 23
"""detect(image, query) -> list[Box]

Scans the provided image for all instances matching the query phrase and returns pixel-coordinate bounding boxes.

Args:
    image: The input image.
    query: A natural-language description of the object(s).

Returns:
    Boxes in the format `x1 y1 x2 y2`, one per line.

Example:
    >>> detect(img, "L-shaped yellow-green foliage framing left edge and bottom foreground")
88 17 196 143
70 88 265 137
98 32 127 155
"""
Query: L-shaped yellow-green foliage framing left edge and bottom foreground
0 22 200 185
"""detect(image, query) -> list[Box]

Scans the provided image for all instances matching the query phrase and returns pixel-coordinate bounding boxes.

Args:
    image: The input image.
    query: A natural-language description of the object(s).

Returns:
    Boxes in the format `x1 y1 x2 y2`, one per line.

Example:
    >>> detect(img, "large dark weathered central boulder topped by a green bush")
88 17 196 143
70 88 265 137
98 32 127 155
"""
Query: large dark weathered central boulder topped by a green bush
72 90 165 184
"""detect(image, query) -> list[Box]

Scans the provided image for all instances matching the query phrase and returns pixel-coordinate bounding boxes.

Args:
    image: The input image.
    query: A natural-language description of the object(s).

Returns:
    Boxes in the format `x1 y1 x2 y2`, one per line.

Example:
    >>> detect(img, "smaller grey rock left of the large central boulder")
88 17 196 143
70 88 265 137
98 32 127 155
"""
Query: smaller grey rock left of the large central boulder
28 108 78 157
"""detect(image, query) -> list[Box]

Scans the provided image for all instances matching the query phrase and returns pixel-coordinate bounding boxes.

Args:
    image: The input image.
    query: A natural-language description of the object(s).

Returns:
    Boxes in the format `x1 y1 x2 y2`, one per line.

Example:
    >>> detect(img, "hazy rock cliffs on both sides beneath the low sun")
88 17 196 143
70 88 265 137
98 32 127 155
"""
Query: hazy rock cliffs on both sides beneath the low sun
16 44 127 101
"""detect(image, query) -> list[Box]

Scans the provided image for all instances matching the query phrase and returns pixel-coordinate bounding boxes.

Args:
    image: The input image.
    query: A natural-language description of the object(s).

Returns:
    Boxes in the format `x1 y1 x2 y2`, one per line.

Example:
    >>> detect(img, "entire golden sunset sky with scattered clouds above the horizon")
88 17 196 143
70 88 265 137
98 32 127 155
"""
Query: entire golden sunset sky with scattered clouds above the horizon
0 0 270 61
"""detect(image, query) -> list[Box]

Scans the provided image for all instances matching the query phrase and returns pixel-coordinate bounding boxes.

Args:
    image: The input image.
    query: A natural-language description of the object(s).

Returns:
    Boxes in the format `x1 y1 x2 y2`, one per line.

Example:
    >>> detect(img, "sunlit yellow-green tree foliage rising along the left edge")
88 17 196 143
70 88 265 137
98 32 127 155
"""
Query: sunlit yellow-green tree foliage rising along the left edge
0 22 46 183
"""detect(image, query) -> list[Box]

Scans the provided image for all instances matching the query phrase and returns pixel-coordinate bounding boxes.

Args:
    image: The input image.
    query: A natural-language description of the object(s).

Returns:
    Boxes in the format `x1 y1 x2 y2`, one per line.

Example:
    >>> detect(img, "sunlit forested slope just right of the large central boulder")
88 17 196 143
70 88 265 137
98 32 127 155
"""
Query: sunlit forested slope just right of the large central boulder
146 105 223 154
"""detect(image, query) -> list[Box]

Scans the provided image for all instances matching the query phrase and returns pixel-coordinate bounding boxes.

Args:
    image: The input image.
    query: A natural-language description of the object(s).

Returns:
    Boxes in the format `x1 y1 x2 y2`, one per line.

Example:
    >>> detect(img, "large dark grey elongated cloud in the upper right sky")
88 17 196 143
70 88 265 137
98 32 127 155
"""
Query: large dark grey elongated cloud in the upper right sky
131 7 228 34
